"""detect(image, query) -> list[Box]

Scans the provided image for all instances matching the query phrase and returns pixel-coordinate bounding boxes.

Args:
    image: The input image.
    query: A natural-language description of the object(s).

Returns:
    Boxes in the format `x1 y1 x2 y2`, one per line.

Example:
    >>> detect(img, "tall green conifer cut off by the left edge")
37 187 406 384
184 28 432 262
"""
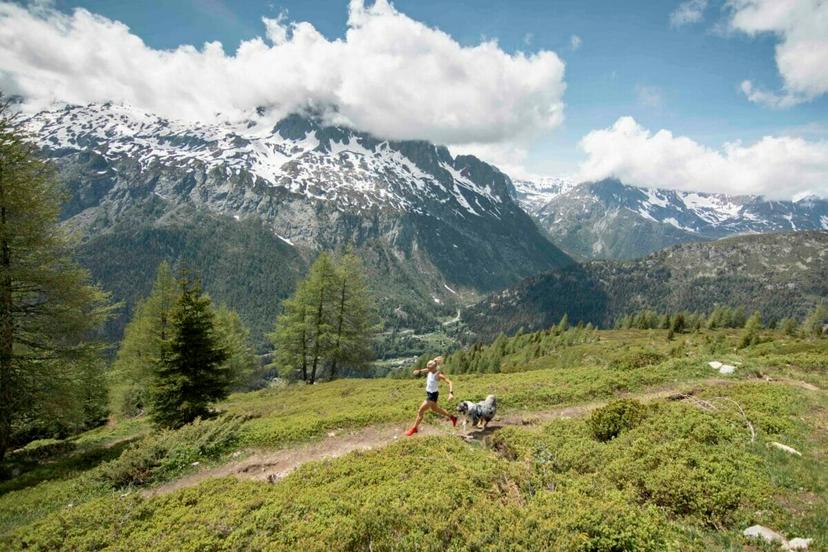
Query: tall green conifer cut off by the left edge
0 98 111 461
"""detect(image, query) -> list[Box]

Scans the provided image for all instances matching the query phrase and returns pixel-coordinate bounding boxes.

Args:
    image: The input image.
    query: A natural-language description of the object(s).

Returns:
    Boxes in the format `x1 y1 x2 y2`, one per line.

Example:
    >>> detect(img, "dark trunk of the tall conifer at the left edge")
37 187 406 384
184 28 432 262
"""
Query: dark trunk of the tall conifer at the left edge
0 179 14 462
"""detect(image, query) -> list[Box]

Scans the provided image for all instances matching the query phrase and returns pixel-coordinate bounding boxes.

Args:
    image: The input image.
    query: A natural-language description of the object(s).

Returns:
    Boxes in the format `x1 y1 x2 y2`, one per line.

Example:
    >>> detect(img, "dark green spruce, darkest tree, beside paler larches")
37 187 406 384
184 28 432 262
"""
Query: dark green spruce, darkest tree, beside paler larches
150 274 232 427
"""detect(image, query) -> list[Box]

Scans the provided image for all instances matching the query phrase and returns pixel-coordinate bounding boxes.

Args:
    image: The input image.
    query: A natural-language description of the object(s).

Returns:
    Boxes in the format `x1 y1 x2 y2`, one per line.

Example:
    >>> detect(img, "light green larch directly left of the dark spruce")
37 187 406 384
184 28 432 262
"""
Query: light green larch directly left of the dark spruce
110 261 178 416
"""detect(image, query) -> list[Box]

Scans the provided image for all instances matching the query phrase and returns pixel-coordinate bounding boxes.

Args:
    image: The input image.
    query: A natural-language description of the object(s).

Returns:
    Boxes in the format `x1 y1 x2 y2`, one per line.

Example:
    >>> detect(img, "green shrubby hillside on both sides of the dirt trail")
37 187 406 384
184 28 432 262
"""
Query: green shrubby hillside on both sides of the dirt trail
0 331 828 550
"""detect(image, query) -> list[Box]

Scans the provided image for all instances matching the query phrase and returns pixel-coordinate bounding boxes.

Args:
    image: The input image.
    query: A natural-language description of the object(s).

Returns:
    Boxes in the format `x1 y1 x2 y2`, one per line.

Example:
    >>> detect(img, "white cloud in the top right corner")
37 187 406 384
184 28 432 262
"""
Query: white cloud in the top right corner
726 0 828 108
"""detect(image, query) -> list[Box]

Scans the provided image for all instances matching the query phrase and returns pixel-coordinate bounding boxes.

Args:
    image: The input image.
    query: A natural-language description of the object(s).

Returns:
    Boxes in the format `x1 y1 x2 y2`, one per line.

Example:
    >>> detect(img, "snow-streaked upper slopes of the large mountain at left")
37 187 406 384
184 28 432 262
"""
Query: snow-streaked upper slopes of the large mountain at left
29 104 508 217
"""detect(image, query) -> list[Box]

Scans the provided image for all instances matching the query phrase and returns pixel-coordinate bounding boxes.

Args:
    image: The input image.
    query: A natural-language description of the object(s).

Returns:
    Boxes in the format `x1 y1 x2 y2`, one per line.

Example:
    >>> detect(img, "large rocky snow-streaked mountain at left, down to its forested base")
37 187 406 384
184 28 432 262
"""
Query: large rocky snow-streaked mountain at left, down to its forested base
27 104 571 338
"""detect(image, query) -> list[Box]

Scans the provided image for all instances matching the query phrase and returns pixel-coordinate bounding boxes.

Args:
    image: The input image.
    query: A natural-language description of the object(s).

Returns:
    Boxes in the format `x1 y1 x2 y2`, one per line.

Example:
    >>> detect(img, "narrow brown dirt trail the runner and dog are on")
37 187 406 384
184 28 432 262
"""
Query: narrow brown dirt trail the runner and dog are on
143 378 813 496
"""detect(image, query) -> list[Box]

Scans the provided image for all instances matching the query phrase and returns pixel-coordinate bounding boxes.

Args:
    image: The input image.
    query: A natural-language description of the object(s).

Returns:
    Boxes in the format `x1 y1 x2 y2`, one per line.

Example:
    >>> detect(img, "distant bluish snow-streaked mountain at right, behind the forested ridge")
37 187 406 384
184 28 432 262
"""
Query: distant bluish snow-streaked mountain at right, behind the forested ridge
516 179 828 259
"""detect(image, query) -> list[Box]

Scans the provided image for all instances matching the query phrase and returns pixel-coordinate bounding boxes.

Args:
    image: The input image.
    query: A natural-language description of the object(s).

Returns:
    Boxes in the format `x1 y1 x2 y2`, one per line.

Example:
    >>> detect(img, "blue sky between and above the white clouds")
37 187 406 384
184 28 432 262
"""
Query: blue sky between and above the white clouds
6 0 828 193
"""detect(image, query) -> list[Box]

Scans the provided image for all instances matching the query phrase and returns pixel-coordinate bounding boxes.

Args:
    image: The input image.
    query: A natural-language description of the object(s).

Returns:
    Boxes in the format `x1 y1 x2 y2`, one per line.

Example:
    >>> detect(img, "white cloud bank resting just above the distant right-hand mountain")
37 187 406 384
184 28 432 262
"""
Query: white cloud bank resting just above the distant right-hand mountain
579 117 828 199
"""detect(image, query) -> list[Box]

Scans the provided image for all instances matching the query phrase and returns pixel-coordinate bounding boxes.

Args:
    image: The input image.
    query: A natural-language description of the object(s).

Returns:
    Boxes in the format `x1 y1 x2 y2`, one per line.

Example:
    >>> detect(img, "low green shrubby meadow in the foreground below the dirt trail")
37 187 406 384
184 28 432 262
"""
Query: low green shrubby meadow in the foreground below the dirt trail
10 381 828 551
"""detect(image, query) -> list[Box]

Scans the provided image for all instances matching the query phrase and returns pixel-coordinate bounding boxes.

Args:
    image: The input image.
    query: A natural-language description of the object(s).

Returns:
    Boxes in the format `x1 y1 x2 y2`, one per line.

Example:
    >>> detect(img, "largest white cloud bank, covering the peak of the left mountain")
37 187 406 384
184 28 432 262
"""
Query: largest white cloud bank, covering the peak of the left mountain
0 0 565 144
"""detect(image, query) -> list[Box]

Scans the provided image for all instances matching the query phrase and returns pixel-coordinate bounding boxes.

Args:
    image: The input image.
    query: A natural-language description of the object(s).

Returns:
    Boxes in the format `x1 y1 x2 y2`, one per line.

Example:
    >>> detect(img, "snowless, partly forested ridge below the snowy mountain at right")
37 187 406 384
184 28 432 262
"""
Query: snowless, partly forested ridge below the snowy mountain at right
462 230 828 341
